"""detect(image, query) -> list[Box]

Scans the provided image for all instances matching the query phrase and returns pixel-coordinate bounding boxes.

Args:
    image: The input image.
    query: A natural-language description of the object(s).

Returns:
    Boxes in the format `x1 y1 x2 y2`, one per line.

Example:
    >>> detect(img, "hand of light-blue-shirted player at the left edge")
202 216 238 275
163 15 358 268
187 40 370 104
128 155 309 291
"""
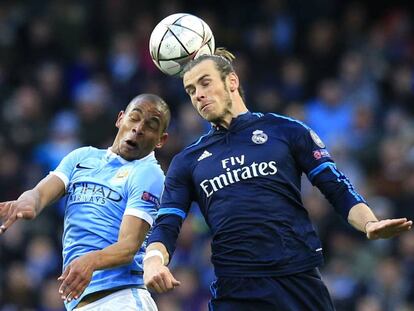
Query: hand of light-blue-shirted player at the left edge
0 199 37 234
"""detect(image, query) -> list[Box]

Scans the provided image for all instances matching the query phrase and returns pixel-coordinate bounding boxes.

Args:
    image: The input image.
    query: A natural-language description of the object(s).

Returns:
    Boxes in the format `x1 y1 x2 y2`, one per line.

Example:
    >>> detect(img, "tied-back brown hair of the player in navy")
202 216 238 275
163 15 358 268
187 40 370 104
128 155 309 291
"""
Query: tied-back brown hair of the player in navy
180 47 246 102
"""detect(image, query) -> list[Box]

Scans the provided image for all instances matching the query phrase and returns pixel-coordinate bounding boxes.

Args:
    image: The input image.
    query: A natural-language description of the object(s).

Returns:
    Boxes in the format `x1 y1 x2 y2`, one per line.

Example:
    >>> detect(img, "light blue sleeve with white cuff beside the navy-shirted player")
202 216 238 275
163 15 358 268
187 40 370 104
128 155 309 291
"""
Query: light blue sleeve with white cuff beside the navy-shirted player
124 164 165 226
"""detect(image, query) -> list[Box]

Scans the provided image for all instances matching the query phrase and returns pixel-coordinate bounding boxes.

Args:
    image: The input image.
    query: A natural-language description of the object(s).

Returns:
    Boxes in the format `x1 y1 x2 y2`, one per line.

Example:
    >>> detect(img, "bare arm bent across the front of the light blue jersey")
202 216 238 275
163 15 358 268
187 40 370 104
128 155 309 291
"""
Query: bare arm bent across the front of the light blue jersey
59 215 150 301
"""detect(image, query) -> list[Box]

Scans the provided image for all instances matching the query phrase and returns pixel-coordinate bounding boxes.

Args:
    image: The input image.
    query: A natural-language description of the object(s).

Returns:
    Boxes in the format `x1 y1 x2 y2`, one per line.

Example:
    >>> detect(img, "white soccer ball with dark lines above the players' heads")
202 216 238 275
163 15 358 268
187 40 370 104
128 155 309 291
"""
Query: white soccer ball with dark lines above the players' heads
149 13 215 75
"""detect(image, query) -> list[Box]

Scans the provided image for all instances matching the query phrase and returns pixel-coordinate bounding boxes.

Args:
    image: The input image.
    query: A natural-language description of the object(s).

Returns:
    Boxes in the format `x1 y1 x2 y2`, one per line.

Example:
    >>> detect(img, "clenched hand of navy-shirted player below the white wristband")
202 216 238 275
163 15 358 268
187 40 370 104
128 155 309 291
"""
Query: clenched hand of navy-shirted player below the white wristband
144 258 181 294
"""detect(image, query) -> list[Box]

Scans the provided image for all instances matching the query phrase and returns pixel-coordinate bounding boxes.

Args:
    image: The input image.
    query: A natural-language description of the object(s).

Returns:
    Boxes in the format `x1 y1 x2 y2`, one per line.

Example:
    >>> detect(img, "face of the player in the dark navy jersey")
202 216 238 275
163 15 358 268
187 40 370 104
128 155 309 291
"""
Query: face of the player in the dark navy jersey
183 60 232 124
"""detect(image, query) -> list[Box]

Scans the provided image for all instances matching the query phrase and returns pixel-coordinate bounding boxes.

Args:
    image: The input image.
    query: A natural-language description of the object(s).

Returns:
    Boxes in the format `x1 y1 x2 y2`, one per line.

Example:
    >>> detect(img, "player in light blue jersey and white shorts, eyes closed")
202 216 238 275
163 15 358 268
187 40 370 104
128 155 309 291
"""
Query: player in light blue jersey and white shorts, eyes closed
0 94 170 311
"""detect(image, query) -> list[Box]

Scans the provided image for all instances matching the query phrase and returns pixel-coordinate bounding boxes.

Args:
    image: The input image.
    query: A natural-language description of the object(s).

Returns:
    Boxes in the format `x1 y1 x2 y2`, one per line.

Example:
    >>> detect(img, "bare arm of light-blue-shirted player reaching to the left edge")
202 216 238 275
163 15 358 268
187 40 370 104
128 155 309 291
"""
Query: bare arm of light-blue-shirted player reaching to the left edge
0 174 65 234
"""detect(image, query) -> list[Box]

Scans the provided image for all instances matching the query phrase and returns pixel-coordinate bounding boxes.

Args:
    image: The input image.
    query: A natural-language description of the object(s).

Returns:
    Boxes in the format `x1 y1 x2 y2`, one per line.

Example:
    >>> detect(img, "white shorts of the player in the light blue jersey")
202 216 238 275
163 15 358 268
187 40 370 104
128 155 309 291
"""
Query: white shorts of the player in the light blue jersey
73 288 158 311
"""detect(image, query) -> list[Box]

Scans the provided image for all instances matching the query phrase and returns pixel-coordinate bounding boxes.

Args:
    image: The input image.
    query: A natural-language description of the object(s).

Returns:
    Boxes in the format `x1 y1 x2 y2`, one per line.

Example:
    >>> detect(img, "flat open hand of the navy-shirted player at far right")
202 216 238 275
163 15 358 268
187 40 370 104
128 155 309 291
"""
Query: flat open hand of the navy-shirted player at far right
365 218 413 240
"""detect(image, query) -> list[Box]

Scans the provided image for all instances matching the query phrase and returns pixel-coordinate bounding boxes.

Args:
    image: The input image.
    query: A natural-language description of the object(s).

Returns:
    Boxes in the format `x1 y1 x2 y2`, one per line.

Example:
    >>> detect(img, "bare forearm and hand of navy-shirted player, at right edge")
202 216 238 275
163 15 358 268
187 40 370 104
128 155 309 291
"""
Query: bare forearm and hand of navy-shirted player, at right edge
348 203 413 240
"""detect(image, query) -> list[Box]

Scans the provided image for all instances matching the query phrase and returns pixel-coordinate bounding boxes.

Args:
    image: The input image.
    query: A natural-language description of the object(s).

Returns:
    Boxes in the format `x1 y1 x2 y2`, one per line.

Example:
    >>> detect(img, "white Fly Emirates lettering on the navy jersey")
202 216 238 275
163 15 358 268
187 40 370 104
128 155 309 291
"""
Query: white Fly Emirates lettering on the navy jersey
200 154 277 197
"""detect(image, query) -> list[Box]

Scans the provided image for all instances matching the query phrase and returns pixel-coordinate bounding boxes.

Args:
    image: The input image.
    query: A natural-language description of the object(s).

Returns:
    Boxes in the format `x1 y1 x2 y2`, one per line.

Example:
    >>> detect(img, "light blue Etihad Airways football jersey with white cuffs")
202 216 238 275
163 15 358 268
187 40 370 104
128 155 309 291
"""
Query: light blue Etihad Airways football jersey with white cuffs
51 147 164 310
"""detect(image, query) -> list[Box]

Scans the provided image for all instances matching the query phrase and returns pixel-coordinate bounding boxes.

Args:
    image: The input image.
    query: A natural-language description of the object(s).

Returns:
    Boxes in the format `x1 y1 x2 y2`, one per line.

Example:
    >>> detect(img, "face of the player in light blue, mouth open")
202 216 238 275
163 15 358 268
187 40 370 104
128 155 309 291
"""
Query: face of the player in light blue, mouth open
112 99 168 161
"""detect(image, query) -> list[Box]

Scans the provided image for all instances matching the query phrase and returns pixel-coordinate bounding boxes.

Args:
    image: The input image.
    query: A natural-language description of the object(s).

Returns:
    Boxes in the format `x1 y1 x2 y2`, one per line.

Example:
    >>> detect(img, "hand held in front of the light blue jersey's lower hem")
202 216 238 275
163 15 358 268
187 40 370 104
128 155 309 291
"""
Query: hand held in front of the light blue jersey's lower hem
58 253 94 302
